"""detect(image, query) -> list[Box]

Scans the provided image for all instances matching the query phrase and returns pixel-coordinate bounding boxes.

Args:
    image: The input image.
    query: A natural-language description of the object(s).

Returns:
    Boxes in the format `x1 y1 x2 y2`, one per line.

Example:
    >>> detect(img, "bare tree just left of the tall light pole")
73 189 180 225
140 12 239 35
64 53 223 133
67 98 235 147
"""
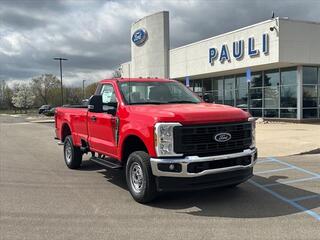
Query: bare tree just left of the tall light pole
31 74 60 104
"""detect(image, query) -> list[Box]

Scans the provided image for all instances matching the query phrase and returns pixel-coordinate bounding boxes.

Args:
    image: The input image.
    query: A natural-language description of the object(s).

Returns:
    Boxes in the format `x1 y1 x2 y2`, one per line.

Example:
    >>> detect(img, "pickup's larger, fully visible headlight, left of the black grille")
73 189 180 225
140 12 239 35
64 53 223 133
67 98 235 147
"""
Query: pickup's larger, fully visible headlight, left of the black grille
154 123 182 157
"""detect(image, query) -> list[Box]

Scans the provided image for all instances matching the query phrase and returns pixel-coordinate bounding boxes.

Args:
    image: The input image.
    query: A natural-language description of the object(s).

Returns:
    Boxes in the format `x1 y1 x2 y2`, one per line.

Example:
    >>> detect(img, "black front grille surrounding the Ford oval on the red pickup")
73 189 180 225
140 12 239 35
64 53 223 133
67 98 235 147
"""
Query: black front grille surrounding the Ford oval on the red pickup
174 122 252 156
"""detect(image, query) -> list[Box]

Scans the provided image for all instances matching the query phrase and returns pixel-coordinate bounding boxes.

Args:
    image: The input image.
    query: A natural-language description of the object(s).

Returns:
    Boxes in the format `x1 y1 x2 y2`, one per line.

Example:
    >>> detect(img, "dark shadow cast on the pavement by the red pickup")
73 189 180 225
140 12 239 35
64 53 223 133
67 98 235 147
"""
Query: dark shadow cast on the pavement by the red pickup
82 160 320 218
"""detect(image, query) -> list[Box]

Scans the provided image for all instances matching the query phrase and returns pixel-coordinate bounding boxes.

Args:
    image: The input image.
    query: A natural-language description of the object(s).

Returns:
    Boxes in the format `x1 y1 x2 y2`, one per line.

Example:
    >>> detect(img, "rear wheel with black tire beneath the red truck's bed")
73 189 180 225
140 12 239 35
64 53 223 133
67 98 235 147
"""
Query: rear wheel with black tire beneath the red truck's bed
63 135 82 169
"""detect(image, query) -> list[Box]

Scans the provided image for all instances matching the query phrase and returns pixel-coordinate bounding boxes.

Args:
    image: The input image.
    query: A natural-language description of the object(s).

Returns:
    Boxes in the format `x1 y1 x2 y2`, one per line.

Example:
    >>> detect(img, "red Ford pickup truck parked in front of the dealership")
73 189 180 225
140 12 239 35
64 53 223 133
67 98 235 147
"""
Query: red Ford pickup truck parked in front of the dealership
55 78 257 203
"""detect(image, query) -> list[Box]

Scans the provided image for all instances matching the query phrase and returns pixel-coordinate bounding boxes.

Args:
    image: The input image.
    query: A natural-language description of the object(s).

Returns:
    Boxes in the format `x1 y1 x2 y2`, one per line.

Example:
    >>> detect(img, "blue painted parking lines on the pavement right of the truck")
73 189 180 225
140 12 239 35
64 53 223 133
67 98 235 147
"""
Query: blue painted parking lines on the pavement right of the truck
249 157 320 221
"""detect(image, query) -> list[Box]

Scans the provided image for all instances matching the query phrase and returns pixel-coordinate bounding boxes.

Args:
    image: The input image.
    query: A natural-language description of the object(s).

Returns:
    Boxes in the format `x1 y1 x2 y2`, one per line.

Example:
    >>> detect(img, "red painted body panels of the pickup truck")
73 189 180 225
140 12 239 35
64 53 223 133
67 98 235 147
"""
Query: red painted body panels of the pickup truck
55 78 249 160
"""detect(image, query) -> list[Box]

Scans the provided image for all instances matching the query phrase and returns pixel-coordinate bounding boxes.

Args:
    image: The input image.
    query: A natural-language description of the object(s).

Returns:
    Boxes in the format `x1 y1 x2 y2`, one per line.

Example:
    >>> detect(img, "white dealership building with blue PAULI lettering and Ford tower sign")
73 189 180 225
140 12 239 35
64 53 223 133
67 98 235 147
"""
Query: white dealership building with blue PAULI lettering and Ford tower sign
121 11 320 120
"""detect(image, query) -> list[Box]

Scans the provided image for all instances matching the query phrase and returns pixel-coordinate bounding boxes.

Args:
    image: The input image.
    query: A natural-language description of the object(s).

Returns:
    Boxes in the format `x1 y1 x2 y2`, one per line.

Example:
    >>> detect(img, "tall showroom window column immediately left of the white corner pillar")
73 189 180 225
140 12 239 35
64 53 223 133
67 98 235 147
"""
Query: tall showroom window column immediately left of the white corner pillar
280 67 297 118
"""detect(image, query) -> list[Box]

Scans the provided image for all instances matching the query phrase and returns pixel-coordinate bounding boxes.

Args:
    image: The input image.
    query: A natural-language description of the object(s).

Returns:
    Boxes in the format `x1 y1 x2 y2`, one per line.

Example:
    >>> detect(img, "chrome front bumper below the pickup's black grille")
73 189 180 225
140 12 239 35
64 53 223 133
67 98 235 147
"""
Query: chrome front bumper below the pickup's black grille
150 148 257 177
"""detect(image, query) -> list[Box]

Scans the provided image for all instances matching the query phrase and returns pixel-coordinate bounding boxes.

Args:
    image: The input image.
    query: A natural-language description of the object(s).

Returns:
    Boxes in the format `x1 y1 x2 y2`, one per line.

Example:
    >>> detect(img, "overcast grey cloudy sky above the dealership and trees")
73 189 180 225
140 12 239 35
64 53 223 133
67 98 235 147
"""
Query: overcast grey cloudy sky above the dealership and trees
0 0 320 86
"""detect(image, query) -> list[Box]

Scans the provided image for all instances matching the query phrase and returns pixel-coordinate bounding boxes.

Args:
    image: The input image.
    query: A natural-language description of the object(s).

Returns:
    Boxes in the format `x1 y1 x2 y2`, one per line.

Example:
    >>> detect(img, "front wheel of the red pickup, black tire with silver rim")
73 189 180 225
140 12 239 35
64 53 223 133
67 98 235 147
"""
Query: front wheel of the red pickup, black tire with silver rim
126 151 157 203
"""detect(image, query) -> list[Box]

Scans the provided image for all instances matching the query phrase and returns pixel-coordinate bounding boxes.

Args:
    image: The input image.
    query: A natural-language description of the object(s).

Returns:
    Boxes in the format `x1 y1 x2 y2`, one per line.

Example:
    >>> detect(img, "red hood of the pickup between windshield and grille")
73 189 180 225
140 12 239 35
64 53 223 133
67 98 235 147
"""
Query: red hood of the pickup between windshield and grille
130 103 249 124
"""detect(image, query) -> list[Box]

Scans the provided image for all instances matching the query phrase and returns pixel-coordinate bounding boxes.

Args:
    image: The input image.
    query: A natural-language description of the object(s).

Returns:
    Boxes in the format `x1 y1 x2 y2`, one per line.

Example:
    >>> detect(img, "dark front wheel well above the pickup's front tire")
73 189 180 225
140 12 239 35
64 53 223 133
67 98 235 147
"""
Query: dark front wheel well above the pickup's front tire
121 135 148 164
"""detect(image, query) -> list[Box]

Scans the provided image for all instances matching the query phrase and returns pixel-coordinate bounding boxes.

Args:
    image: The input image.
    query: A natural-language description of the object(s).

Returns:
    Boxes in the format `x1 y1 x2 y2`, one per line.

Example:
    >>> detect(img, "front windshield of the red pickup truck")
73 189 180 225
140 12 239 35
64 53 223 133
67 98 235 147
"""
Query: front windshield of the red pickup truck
120 81 201 105
